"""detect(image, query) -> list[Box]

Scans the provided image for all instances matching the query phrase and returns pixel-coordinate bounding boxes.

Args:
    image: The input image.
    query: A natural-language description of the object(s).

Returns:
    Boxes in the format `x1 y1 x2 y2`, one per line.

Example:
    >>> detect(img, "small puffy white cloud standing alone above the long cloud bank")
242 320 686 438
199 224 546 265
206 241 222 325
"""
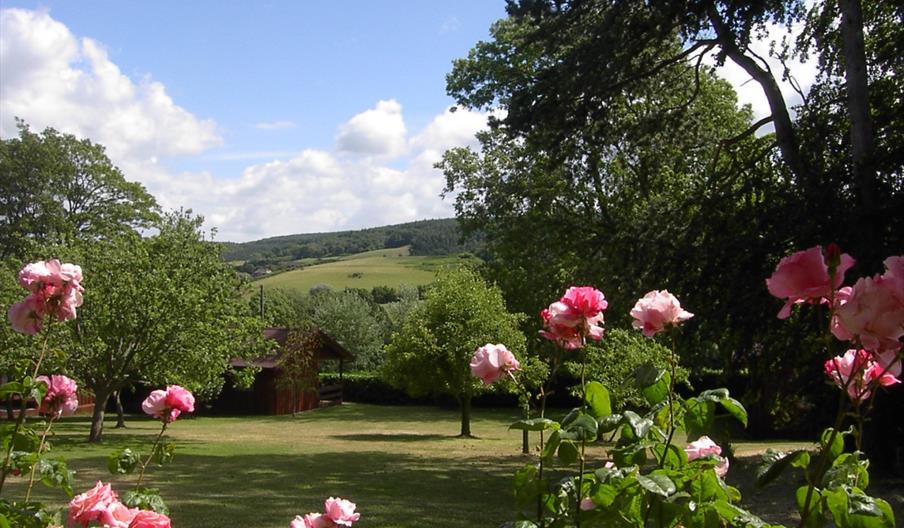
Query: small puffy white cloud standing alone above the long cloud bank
336 99 408 158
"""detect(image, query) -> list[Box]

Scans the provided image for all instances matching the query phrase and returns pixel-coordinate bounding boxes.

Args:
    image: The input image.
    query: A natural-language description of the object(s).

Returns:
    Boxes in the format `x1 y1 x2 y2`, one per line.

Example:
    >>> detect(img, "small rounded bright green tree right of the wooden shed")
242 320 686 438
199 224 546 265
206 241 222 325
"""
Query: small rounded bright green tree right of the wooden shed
383 268 525 436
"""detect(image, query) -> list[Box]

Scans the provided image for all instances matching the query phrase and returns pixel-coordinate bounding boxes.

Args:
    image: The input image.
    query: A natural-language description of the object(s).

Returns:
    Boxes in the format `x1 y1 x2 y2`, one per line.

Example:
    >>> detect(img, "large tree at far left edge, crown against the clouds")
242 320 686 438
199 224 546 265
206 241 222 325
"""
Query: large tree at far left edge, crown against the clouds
0 121 158 259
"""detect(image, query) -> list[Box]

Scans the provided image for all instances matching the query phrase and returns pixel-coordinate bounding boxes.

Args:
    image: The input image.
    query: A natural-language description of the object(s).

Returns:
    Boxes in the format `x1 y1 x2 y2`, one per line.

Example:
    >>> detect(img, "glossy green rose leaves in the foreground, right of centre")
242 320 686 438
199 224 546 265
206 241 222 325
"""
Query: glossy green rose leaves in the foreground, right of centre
511 374 756 528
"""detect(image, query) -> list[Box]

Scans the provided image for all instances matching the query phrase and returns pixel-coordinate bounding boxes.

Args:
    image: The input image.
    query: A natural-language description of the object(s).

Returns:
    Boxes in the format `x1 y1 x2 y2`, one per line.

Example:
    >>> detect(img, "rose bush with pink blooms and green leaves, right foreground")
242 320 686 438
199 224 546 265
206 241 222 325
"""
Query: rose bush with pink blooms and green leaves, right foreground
497 245 904 528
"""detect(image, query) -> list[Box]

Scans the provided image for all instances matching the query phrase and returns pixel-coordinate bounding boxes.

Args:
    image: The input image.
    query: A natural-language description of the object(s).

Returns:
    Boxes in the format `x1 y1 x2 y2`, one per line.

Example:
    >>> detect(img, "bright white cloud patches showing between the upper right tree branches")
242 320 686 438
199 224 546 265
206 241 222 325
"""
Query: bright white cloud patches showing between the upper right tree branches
706 23 817 123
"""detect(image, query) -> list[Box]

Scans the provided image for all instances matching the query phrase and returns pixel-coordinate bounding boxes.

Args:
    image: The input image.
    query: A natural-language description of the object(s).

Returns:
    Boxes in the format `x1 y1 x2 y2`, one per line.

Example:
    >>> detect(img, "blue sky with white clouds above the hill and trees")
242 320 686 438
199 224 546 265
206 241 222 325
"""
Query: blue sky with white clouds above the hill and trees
0 0 812 242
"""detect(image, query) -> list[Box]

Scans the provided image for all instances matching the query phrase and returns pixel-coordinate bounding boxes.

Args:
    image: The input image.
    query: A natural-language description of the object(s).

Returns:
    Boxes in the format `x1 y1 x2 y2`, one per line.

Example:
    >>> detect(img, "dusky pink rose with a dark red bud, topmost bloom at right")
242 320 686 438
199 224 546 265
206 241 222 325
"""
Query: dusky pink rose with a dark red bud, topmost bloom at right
766 246 855 319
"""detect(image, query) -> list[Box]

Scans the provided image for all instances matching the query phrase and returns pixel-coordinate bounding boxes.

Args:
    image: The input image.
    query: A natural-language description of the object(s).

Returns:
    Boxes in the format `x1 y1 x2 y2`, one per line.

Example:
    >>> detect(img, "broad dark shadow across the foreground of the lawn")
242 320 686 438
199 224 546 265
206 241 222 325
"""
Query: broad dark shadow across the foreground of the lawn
14 451 523 528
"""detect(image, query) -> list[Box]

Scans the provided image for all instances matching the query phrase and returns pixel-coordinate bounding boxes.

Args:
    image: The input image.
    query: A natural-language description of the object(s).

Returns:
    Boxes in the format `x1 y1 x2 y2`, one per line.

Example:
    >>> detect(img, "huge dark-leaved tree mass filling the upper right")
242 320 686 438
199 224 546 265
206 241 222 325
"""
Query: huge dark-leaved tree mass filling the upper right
443 0 904 434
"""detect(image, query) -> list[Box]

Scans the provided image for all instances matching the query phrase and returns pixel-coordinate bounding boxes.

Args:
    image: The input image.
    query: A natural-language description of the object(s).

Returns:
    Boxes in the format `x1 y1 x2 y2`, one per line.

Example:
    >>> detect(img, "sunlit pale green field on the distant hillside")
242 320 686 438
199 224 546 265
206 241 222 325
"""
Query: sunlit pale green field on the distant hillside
247 246 474 293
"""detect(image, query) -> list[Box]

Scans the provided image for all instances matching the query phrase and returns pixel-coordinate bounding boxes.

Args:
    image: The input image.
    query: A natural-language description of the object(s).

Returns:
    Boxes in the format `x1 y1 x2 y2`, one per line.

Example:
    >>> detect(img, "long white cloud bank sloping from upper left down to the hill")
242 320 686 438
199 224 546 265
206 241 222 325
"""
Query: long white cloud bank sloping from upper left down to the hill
0 9 487 241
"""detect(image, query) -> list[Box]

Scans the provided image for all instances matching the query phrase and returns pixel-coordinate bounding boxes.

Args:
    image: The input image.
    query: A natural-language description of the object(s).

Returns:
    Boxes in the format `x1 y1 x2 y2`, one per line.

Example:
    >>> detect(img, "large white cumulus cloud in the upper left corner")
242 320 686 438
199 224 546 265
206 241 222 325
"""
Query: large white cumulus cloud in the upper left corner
0 9 221 160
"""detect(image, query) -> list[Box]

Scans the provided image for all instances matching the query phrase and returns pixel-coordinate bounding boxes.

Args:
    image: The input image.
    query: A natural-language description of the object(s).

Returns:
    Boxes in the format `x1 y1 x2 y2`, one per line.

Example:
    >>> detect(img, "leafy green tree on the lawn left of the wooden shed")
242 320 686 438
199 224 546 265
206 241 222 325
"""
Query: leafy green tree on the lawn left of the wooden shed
64 212 262 441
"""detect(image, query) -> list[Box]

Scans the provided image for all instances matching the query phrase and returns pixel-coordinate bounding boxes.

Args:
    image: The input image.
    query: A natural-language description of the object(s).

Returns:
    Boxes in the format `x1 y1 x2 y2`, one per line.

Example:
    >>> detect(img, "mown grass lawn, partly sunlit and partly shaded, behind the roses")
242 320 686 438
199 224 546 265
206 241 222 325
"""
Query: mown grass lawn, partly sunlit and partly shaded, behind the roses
9 404 904 528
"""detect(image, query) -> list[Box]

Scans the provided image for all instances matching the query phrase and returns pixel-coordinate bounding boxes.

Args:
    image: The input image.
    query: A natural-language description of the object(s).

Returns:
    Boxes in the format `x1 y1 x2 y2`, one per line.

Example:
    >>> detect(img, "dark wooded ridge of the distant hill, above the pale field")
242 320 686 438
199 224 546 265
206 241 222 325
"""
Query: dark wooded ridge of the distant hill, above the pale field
223 218 483 274
